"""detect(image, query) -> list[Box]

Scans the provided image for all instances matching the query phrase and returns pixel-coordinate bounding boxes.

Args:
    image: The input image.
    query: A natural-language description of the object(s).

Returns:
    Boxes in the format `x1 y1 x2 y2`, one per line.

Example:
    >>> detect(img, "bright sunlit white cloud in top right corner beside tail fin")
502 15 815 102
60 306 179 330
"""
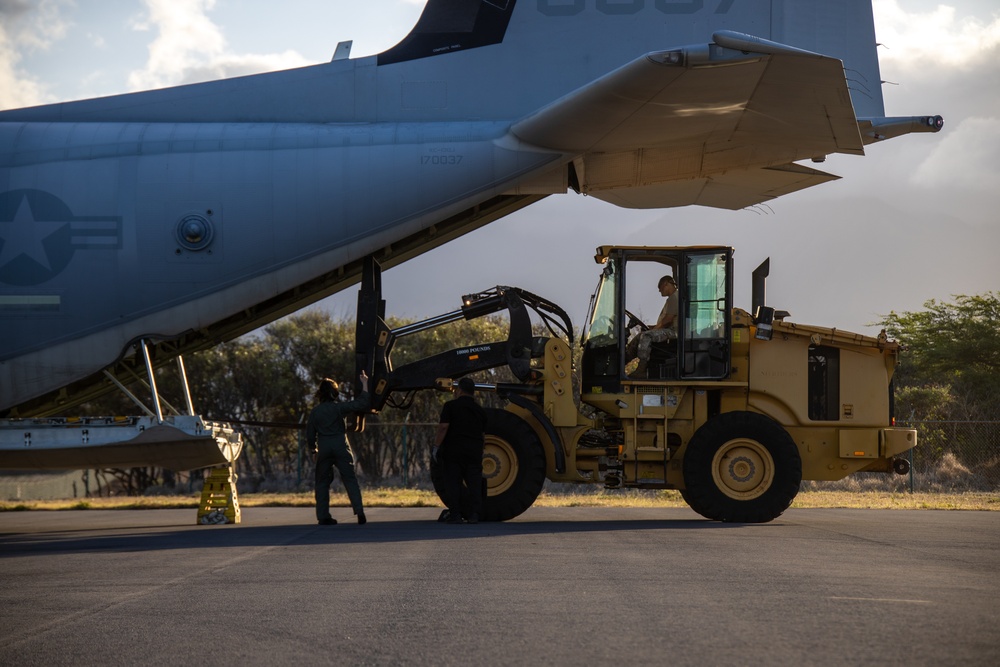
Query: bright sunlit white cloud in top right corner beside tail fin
873 0 1000 68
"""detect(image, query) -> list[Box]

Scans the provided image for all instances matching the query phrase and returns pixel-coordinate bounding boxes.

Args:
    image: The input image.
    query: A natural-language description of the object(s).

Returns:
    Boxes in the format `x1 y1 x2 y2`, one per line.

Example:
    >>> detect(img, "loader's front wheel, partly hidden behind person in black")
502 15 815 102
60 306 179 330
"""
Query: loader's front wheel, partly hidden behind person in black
431 408 545 521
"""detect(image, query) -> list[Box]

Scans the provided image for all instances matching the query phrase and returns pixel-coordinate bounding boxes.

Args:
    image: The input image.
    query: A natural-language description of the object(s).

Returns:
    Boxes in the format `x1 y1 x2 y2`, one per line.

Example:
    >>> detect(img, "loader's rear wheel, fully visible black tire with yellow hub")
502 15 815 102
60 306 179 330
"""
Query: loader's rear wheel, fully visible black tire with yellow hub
681 412 802 523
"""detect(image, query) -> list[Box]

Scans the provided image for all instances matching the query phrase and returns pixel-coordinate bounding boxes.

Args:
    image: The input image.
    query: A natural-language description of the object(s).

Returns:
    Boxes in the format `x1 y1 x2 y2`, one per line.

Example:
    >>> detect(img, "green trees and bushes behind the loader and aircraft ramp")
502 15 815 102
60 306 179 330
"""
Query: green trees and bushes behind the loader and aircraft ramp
85 292 1000 493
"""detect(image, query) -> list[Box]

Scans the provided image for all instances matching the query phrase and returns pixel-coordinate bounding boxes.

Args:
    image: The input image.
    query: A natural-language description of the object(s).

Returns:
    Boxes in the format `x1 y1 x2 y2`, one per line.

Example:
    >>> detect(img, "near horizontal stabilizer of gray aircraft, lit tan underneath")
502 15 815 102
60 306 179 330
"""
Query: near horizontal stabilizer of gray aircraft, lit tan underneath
513 35 864 161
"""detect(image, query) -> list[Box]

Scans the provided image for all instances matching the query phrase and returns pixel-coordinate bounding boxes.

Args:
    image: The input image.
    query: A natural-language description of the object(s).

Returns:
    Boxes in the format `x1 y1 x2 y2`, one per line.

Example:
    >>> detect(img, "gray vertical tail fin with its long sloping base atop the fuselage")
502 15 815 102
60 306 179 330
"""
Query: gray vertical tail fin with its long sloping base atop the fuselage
0 0 884 128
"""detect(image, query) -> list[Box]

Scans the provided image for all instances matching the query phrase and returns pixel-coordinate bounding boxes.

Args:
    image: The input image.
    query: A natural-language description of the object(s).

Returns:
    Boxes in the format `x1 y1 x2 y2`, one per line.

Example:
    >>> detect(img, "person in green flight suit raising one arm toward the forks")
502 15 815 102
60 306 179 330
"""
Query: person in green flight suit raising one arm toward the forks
306 371 368 526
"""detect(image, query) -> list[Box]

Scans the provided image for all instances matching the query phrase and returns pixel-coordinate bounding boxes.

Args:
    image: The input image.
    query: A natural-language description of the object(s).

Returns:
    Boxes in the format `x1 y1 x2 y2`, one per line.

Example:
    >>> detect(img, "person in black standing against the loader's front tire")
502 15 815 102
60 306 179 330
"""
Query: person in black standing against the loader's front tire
431 378 486 523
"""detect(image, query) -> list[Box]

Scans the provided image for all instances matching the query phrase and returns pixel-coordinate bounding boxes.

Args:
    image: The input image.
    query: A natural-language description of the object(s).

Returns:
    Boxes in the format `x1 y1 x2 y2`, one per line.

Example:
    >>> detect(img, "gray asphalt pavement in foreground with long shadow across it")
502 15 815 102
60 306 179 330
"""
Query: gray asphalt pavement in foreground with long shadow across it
0 507 1000 666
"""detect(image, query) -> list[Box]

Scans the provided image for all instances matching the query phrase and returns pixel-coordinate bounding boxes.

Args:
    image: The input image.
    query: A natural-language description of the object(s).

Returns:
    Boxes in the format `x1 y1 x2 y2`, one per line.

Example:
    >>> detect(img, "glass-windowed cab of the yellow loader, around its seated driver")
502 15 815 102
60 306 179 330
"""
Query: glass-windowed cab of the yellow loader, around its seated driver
581 246 733 393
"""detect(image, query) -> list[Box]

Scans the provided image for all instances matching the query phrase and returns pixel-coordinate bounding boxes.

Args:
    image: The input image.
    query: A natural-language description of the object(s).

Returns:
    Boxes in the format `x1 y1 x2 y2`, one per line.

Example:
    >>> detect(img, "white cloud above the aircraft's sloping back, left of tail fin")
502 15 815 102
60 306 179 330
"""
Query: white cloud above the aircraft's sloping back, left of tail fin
129 0 309 90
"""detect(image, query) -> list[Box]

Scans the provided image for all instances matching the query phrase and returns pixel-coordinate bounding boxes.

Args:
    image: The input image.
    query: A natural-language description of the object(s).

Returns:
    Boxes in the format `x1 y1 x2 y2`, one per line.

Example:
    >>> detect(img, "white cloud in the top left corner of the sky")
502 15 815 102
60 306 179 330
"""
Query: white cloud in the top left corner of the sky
0 0 72 109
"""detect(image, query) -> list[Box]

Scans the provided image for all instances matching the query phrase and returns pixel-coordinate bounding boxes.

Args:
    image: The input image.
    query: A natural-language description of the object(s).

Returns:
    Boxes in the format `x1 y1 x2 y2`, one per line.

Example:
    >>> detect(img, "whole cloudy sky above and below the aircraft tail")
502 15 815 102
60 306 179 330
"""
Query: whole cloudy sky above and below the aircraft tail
0 0 1000 334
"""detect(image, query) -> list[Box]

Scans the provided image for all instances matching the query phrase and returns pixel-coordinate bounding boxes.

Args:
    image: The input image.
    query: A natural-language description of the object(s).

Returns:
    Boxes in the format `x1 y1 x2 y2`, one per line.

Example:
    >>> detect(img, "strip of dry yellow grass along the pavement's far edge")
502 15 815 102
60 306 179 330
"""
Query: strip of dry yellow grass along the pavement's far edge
0 487 1000 512
